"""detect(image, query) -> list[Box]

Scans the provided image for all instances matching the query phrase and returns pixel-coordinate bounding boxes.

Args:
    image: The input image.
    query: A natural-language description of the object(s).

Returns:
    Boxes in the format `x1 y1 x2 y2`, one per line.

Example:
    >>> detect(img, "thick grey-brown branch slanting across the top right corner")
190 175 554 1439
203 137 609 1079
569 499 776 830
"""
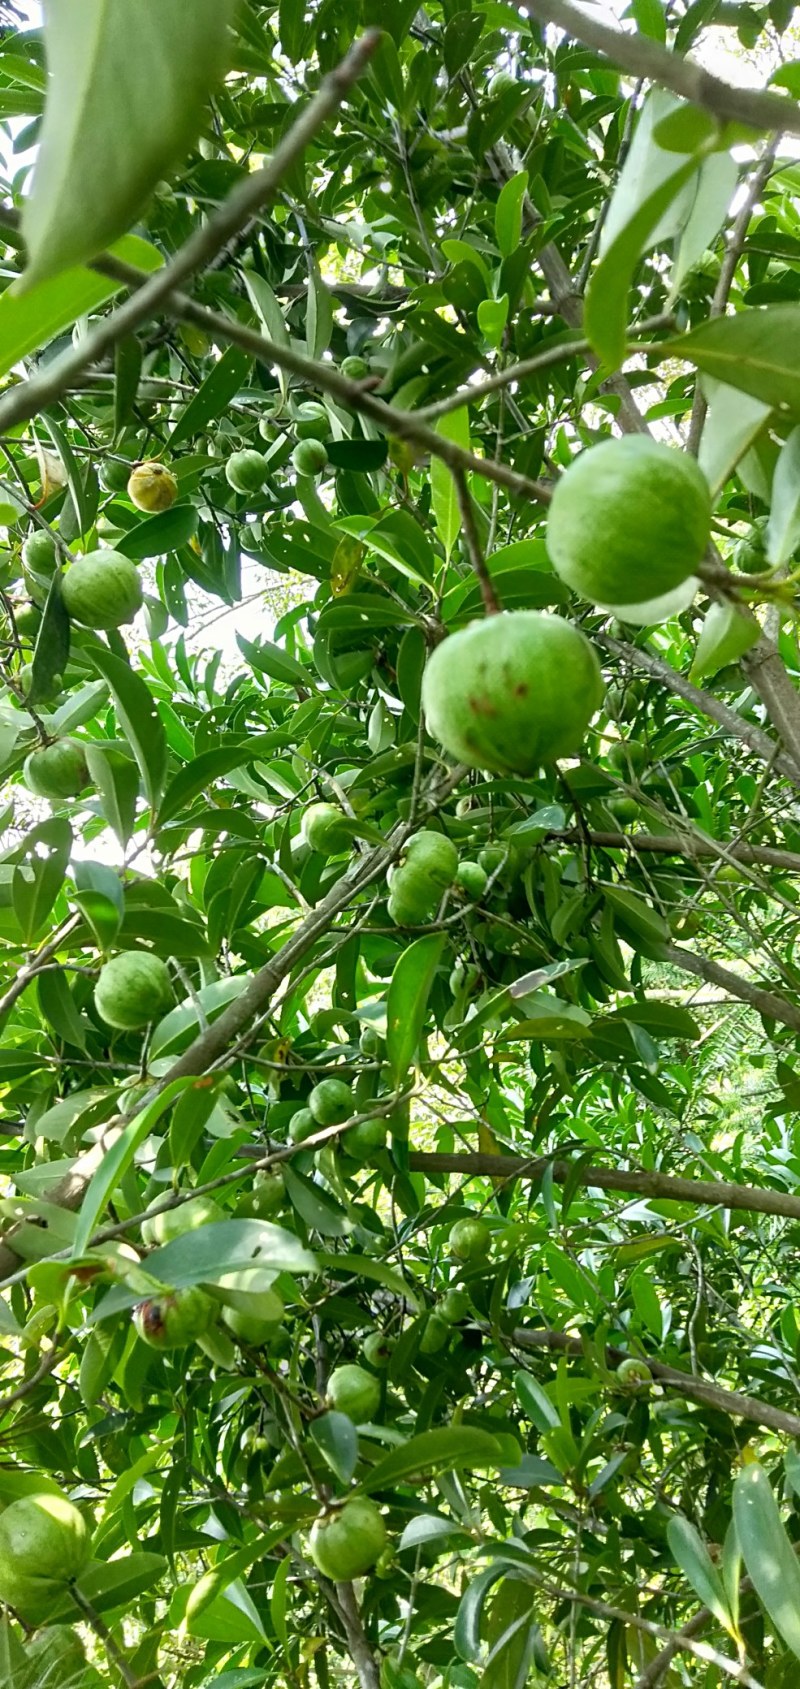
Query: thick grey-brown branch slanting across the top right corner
520 0 800 135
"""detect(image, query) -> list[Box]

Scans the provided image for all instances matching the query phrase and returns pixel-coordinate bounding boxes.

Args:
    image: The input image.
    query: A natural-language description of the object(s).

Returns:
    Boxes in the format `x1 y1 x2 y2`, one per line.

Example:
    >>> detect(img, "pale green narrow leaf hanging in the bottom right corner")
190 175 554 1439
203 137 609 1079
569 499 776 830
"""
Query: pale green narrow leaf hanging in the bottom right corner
732 1464 800 1660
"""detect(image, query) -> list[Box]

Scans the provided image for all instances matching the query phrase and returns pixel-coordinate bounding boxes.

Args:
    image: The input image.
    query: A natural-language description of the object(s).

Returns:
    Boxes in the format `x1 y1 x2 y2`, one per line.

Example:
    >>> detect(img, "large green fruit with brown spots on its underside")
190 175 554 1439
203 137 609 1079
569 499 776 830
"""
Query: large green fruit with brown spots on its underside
422 610 603 774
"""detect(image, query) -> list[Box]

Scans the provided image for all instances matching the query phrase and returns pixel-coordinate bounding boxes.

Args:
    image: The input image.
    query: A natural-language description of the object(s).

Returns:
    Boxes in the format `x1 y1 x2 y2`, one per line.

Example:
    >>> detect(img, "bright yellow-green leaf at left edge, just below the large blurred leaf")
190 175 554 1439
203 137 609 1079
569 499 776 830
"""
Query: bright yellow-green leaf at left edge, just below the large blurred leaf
0 235 164 375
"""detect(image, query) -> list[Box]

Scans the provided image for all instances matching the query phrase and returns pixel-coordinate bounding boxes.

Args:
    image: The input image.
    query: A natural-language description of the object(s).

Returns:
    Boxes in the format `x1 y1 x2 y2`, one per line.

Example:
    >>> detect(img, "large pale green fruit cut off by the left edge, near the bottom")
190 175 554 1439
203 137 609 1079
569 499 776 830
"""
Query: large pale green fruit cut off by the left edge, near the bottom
0 1495 89 1625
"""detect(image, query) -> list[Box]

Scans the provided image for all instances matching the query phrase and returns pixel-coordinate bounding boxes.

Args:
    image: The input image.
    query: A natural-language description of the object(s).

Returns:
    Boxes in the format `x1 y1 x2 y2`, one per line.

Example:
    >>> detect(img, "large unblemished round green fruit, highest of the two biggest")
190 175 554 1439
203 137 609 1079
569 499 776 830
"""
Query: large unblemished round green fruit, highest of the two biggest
547 434 711 610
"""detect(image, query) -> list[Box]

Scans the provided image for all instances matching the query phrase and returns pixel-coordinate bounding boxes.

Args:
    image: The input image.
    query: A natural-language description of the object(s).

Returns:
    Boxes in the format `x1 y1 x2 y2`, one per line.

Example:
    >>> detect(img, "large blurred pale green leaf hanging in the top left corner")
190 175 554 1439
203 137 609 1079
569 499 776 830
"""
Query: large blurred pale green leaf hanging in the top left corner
22 0 233 285
